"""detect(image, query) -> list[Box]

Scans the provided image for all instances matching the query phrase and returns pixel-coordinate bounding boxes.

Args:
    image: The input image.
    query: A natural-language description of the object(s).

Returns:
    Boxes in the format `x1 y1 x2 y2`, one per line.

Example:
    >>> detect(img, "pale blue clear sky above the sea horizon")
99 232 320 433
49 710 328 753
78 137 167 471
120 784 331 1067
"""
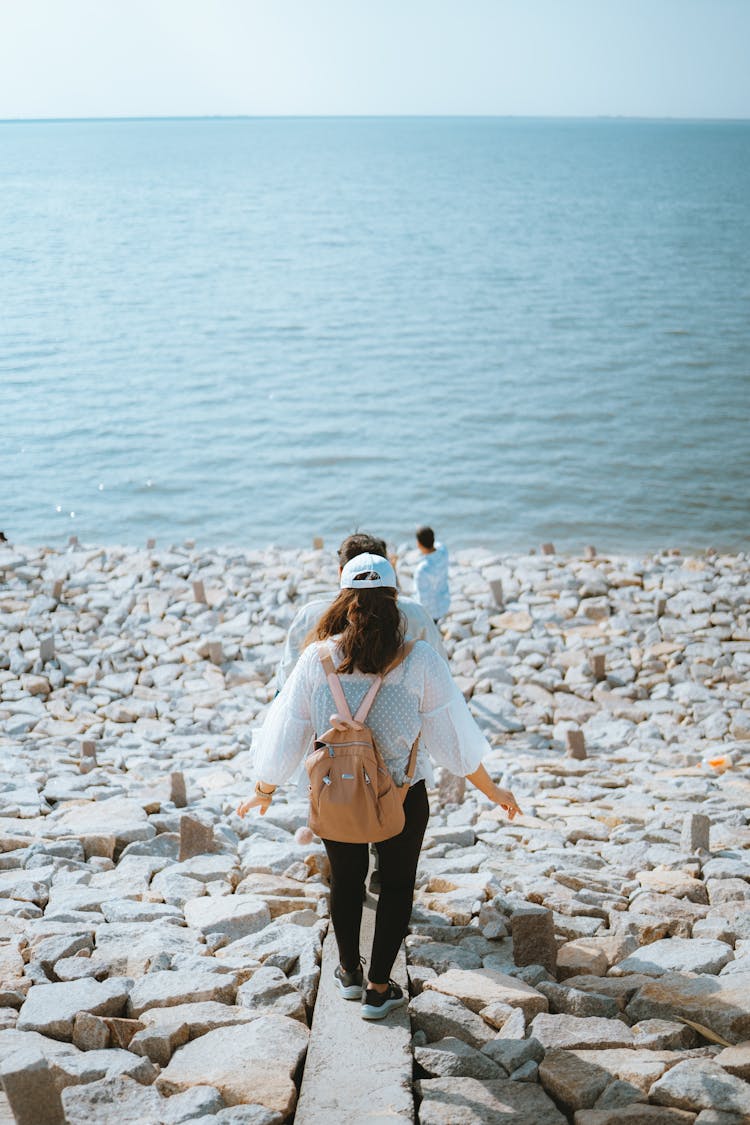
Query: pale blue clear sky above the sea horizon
0 0 750 118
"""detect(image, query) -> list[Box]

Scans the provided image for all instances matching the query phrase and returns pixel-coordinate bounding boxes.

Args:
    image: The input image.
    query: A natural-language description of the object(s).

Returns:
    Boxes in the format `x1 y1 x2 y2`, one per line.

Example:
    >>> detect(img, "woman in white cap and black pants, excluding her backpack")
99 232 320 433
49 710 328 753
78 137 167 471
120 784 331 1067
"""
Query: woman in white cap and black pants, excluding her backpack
237 555 521 1019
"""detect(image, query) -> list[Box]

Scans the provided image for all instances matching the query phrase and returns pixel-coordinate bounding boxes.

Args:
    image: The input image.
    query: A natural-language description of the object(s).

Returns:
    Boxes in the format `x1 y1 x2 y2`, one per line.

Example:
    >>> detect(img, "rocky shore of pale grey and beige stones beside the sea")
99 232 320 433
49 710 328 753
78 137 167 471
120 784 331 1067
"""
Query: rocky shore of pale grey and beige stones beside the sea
0 543 750 1125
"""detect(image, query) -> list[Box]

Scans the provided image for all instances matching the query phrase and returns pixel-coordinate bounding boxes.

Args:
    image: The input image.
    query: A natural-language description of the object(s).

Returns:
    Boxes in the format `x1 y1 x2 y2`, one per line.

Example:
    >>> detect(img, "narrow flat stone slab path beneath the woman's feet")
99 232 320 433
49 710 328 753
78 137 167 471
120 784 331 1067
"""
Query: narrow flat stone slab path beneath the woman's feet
295 897 414 1125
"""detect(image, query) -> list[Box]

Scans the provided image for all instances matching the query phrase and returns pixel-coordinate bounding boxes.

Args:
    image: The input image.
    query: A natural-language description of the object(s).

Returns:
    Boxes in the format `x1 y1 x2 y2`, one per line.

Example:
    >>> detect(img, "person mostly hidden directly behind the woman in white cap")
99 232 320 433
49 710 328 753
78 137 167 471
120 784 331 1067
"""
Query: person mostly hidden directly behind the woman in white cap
275 532 448 691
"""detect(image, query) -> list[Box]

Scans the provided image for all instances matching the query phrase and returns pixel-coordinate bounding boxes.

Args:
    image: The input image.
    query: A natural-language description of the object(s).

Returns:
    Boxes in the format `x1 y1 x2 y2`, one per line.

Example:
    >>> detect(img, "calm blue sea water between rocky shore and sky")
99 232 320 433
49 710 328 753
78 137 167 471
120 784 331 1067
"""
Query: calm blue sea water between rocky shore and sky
0 119 750 550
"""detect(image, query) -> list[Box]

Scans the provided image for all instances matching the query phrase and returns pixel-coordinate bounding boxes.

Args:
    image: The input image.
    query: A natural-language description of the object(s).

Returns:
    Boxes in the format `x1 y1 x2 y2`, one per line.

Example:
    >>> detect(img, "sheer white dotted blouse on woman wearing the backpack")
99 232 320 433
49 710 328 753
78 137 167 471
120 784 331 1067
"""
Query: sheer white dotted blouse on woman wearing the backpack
253 640 490 785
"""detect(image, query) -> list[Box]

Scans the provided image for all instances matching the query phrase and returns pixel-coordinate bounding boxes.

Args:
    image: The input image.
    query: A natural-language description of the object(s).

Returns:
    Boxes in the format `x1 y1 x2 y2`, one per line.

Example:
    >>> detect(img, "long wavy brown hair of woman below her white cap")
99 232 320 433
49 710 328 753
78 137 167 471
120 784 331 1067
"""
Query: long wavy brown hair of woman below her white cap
305 586 404 672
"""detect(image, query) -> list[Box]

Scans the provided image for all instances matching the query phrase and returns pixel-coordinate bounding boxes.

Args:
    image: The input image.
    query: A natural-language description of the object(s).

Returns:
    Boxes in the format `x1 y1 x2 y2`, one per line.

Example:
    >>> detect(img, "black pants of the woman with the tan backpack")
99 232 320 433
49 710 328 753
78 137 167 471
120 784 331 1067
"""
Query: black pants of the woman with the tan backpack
323 781 430 984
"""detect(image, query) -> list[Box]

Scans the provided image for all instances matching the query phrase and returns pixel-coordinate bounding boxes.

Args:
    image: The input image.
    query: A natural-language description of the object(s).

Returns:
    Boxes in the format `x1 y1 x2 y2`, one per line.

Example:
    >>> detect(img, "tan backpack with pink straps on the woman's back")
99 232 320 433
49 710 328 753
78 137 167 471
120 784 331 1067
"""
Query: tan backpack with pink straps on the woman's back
305 641 419 844
